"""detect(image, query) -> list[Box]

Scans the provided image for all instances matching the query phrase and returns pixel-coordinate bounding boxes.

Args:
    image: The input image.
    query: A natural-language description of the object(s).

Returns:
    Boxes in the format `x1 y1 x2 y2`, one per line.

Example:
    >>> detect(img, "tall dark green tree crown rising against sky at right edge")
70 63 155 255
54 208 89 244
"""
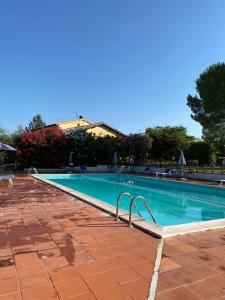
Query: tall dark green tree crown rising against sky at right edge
187 63 225 142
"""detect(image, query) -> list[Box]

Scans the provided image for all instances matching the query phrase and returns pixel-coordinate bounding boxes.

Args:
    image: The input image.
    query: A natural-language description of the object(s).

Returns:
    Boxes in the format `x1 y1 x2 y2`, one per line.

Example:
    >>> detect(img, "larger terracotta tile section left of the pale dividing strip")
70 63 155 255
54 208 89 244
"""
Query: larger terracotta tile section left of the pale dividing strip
0 176 158 300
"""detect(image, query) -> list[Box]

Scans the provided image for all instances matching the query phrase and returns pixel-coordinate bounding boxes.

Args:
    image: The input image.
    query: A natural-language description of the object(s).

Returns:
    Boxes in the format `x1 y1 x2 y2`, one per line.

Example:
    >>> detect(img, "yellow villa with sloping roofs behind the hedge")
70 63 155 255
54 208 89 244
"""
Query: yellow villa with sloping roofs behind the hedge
43 116 125 137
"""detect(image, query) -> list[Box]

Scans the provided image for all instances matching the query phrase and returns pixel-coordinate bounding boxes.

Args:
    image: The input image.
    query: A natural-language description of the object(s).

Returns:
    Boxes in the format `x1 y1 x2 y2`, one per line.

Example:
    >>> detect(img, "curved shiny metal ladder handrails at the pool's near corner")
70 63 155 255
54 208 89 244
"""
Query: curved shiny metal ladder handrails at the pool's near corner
116 192 156 227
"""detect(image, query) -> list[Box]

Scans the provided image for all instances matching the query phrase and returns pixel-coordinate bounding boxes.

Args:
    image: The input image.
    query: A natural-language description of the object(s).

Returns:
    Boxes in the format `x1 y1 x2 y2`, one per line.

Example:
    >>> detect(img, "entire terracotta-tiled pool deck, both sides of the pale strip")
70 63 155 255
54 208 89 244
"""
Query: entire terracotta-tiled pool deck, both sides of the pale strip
0 176 225 300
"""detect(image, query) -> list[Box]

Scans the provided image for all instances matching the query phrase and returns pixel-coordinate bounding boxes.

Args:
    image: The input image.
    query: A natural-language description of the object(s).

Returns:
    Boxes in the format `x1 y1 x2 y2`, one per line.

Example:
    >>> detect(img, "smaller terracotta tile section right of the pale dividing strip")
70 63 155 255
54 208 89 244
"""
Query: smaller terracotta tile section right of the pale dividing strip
156 229 225 300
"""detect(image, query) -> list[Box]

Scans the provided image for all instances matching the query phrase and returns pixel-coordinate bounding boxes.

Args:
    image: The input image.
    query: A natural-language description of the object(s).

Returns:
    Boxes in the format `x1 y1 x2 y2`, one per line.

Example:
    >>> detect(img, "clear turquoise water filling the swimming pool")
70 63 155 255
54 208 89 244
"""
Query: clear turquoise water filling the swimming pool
39 174 225 226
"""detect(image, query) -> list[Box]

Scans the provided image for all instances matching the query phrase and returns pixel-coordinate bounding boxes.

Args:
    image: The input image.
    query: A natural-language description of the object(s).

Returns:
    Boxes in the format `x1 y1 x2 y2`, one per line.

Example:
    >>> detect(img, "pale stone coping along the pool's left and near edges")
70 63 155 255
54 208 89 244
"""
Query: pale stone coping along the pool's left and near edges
31 174 225 238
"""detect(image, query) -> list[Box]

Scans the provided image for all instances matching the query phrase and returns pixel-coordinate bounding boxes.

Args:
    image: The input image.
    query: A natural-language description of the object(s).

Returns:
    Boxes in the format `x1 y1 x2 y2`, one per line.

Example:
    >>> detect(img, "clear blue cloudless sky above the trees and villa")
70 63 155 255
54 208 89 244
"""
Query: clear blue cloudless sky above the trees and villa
0 0 225 136
